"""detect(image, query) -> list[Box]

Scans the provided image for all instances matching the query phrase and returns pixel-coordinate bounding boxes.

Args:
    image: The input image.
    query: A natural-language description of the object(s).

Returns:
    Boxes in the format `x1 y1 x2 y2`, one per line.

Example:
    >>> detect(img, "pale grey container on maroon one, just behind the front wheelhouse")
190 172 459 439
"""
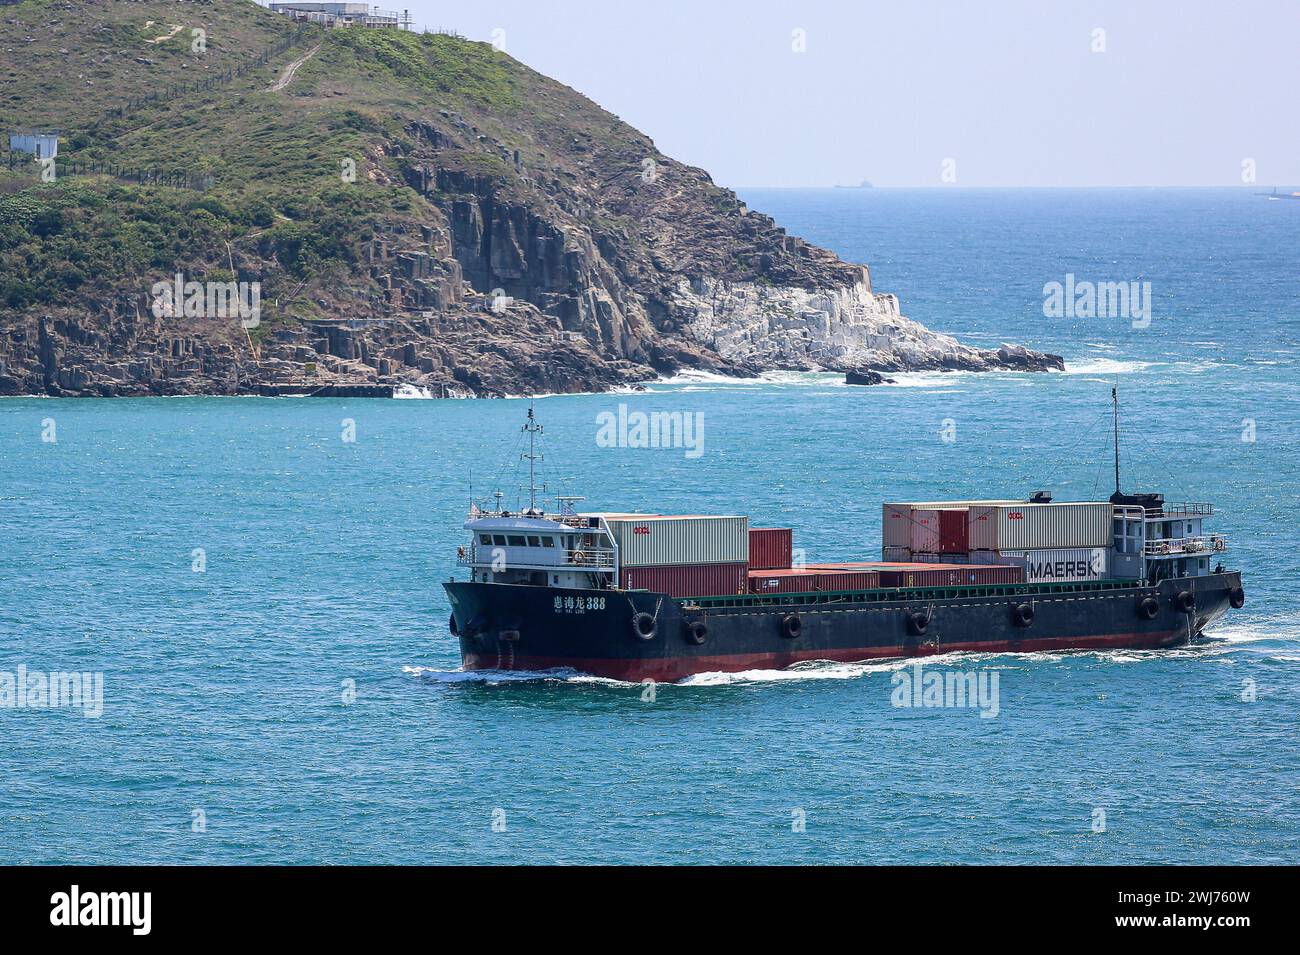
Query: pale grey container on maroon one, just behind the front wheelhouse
584 515 749 567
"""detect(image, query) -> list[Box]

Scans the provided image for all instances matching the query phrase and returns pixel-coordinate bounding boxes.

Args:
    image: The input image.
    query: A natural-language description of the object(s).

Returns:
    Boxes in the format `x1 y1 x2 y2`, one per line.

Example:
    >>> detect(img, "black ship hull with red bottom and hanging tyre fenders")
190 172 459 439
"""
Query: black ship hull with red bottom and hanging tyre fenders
443 572 1244 682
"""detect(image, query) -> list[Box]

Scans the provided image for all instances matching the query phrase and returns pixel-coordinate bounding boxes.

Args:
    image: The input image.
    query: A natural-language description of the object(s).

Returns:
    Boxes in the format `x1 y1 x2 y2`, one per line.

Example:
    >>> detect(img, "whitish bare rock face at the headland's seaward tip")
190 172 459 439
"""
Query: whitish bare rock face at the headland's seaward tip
673 273 998 370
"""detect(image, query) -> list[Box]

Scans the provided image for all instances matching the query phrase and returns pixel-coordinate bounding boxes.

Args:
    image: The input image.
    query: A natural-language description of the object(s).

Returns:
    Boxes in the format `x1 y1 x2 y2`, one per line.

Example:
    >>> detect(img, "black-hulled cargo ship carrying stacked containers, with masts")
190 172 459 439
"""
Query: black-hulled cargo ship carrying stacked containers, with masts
443 405 1245 681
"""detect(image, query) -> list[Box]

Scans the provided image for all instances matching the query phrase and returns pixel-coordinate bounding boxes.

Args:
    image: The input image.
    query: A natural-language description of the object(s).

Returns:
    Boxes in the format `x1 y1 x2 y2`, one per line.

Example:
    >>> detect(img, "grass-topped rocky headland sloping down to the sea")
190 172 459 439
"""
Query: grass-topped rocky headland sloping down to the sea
0 0 1061 395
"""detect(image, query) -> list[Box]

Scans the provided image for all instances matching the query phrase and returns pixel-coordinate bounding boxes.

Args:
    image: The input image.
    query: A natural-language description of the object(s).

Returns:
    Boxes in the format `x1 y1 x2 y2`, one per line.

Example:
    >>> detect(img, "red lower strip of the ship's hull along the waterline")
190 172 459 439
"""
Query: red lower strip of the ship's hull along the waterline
463 630 1187 683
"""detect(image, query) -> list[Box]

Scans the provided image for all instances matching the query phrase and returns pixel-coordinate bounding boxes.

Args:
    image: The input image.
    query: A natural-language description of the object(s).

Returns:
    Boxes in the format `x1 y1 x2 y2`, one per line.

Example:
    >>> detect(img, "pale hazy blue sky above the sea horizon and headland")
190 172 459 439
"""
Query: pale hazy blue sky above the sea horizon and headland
269 0 1300 187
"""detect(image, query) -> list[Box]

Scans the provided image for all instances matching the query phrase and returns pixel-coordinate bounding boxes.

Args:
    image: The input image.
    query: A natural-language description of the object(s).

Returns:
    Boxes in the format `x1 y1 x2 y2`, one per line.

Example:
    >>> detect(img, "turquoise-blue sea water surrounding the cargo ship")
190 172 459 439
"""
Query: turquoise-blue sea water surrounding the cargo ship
0 190 1300 864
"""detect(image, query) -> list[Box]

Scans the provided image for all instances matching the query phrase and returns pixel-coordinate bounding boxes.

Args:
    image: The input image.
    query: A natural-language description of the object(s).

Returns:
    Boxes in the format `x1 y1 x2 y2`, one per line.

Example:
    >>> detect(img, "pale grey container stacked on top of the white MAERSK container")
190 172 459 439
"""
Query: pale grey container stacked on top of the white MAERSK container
970 502 1114 551
